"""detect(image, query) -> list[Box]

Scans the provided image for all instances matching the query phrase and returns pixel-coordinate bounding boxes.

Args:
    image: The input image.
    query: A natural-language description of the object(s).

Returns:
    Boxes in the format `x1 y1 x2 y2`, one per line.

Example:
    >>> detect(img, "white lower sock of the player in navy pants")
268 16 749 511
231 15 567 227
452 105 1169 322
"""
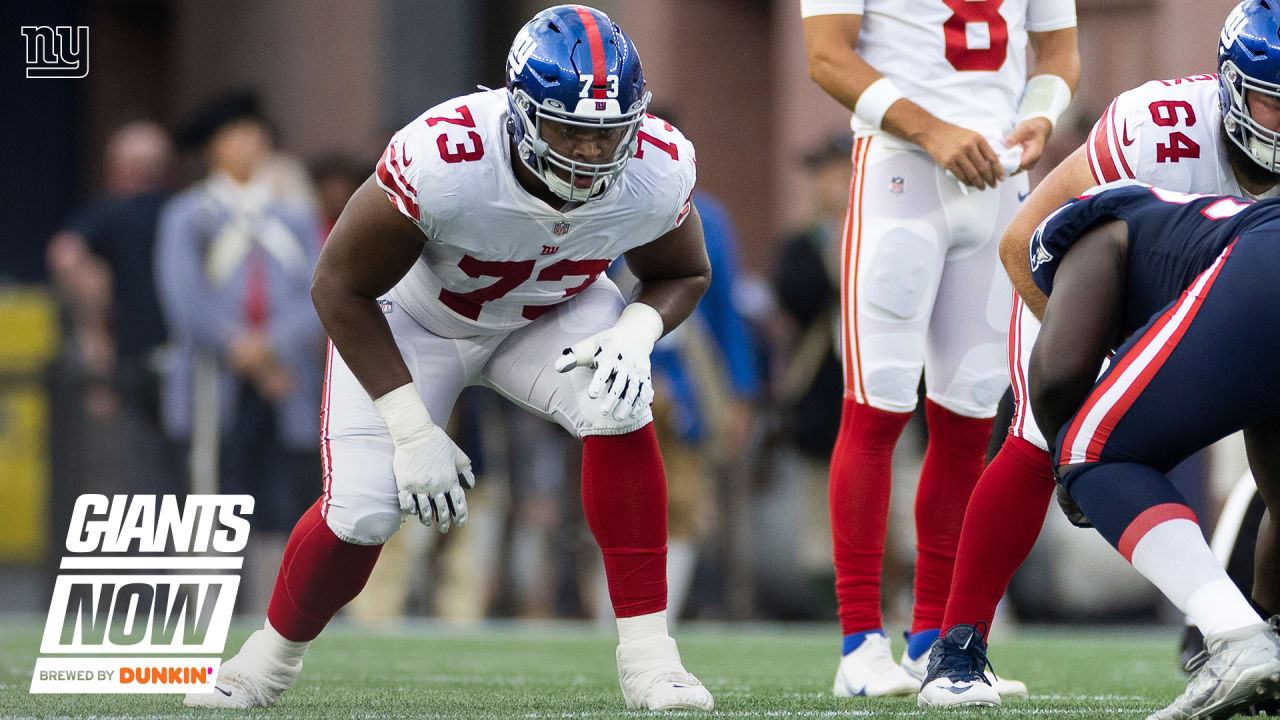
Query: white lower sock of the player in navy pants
1130 518 1262 635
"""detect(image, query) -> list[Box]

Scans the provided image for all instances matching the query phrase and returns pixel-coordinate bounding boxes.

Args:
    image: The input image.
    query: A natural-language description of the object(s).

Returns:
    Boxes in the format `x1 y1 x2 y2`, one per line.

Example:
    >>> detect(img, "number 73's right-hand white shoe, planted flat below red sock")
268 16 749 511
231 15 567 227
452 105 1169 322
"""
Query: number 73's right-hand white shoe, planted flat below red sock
617 635 716 710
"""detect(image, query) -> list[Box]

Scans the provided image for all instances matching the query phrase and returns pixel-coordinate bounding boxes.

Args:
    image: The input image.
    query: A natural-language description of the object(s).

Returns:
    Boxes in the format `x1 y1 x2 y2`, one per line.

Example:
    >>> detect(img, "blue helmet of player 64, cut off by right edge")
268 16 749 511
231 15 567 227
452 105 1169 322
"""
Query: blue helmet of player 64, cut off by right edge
1217 0 1280 173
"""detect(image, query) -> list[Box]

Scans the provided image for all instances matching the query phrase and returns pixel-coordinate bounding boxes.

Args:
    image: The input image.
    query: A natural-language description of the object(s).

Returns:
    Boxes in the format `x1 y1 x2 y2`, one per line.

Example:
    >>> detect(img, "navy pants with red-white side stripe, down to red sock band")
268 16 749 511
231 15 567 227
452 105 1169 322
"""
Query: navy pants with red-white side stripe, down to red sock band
1053 231 1280 559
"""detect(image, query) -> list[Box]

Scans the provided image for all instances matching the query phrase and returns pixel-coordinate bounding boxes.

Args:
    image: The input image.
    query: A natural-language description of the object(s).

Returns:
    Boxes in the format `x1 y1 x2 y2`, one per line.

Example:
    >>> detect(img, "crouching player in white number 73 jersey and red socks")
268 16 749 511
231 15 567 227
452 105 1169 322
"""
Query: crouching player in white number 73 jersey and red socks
187 5 713 710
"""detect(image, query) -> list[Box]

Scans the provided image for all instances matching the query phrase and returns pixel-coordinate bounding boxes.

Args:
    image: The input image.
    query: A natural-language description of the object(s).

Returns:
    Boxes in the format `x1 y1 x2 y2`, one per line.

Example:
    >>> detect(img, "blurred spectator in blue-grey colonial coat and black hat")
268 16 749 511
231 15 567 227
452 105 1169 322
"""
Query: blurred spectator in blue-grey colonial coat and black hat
156 88 324 597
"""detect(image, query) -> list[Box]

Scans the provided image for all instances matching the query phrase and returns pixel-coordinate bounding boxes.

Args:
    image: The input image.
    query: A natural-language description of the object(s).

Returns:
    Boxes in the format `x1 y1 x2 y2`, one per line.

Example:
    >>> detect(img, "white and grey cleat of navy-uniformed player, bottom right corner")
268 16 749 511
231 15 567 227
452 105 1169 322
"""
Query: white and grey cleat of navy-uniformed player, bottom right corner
1147 618 1280 720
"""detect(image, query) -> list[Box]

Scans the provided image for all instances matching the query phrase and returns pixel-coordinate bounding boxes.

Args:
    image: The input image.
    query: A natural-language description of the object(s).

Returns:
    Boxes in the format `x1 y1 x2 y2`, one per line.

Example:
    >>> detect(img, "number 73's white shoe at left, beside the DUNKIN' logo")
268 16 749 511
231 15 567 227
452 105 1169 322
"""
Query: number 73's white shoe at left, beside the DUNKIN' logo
183 630 302 708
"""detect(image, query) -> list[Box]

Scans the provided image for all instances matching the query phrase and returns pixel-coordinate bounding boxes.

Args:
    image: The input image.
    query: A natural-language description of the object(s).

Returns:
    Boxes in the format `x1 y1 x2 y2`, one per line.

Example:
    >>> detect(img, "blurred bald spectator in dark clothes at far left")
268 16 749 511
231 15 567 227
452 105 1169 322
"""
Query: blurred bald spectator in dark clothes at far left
46 120 182 535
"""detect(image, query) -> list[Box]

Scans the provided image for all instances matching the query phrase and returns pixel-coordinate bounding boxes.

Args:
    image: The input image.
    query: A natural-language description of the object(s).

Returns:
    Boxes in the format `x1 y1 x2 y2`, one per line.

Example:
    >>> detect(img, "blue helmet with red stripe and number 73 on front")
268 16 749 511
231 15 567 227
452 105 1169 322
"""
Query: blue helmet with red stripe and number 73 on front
507 5 650 202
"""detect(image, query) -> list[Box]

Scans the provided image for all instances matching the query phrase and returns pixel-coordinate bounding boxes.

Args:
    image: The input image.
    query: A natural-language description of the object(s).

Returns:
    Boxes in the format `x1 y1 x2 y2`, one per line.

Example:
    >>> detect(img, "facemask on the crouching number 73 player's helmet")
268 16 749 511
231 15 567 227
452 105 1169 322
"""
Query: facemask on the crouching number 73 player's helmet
511 87 652 202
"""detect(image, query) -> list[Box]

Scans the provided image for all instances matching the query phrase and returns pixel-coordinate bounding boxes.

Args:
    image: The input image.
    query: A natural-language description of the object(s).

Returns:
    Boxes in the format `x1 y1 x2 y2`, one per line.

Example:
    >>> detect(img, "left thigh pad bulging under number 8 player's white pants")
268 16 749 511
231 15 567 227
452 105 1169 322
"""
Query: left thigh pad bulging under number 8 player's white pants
860 227 937 320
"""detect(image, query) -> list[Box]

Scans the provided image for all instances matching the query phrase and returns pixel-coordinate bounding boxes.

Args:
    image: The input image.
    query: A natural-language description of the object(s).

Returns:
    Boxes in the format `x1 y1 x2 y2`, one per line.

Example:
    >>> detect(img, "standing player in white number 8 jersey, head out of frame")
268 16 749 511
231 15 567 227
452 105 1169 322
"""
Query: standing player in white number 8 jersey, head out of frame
801 0 1079 696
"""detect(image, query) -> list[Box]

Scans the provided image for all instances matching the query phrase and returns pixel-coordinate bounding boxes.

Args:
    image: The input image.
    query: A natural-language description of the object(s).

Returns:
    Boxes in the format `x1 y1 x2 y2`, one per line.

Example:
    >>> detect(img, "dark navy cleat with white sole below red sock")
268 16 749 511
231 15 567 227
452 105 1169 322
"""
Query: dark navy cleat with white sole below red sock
915 625 1003 707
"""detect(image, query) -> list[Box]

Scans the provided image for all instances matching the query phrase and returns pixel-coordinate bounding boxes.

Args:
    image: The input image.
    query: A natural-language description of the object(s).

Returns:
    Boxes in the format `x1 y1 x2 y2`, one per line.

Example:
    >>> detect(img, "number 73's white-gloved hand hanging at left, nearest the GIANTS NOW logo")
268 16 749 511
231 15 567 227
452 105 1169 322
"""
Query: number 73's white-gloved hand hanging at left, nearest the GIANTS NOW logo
392 423 476 533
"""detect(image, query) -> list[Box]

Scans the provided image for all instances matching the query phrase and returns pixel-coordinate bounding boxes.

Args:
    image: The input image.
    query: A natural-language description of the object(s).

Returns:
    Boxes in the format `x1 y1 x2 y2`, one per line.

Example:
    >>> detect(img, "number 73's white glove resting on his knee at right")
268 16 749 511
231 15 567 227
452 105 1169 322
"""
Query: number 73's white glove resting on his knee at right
556 302 663 421
